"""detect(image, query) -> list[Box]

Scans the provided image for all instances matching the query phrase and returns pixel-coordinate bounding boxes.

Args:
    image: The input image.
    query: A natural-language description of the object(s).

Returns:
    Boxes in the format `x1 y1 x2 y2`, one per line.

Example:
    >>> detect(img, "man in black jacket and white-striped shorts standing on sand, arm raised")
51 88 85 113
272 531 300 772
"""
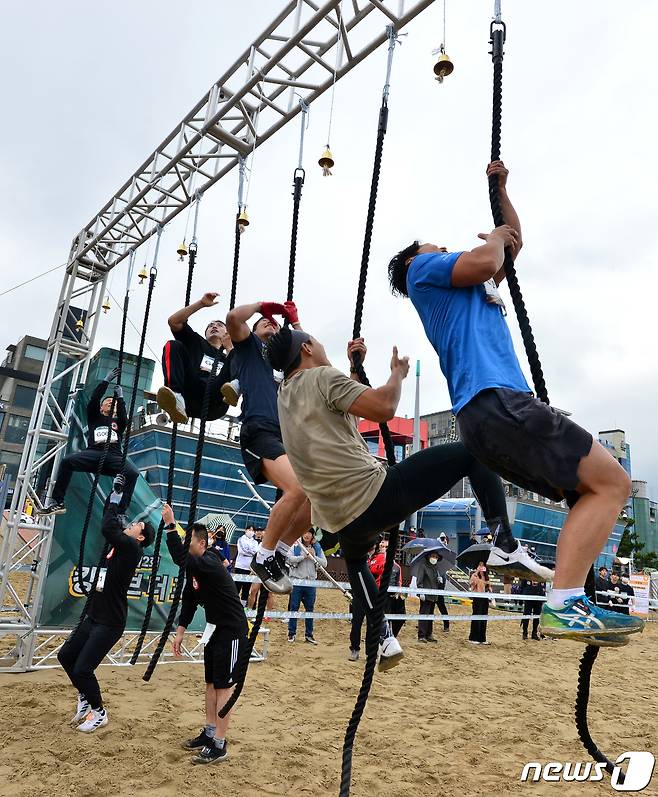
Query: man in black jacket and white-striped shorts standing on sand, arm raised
162 504 247 764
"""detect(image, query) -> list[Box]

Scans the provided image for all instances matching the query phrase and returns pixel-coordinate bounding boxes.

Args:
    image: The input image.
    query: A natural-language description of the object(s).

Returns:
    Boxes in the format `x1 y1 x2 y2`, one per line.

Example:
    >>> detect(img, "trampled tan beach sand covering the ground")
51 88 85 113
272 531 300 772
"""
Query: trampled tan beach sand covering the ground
0 591 658 797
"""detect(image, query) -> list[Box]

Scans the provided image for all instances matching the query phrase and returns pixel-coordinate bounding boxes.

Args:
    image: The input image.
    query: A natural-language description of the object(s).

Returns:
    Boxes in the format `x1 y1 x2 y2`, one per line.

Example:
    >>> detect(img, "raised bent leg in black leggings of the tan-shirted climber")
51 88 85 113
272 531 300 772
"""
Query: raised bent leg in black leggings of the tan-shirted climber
338 443 509 569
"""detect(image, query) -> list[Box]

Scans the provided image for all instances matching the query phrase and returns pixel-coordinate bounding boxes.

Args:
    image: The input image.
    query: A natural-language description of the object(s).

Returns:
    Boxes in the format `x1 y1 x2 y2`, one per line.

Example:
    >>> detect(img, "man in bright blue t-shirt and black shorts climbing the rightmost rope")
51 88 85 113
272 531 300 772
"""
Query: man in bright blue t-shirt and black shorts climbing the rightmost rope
389 161 644 645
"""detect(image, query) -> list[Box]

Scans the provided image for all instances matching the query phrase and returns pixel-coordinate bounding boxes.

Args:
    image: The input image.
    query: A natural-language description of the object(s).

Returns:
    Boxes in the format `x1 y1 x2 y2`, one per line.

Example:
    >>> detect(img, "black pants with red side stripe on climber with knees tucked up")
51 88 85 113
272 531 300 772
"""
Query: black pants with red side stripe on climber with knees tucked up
162 340 231 421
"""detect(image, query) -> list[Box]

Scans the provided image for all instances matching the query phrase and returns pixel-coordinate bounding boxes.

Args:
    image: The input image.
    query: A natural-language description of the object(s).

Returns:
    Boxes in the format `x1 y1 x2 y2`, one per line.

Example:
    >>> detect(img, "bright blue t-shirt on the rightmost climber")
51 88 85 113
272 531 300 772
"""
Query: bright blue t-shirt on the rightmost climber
407 252 531 414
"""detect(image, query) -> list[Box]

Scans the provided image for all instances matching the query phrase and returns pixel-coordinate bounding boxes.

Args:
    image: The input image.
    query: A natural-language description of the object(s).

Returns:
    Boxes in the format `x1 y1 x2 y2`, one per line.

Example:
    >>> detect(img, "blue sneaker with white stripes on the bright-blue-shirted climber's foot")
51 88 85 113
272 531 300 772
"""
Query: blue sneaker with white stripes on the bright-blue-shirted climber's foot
539 595 644 647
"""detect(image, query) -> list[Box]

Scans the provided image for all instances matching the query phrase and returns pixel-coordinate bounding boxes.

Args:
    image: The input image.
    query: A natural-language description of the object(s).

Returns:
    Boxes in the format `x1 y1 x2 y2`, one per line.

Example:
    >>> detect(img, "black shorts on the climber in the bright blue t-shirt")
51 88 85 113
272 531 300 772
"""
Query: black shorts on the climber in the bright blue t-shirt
457 388 592 503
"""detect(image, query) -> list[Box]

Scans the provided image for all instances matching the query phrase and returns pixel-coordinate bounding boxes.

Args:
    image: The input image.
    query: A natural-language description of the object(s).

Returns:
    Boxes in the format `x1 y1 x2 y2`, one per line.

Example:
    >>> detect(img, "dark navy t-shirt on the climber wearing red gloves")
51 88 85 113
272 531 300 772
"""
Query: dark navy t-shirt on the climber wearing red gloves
231 332 279 425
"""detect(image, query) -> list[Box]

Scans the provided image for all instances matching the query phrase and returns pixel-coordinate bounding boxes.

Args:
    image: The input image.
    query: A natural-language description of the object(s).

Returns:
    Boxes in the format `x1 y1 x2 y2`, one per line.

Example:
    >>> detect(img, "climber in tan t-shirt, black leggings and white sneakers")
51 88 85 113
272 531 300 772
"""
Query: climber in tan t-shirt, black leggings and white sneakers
266 328 552 669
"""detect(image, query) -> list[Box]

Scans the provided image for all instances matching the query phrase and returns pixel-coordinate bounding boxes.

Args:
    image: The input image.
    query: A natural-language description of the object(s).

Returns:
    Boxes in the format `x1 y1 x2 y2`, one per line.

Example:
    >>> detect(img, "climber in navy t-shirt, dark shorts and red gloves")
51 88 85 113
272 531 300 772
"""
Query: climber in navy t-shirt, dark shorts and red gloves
226 302 311 593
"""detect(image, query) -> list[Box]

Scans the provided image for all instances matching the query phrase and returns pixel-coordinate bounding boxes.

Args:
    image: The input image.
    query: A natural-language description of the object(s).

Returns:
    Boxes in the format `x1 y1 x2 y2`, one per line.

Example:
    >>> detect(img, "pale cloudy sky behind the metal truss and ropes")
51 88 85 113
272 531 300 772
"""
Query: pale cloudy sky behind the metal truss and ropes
0 0 658 498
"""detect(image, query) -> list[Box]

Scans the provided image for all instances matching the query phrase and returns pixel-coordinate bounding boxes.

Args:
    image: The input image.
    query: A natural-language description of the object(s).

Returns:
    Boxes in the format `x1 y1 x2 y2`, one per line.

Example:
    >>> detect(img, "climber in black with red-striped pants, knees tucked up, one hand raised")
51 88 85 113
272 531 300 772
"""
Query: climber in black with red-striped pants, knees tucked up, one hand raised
157 291 233 423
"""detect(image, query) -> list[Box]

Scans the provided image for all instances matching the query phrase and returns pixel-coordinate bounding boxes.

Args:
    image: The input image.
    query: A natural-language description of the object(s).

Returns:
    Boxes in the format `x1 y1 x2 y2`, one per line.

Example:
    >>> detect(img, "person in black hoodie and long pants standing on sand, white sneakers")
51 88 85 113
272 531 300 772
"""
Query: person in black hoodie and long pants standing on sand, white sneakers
57 476 155 733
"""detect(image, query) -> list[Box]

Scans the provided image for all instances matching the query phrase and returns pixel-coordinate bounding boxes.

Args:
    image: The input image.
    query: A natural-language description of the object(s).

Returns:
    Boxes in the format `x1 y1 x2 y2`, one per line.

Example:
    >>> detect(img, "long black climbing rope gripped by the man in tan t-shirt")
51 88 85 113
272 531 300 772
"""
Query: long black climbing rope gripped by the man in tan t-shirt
339 26 398 797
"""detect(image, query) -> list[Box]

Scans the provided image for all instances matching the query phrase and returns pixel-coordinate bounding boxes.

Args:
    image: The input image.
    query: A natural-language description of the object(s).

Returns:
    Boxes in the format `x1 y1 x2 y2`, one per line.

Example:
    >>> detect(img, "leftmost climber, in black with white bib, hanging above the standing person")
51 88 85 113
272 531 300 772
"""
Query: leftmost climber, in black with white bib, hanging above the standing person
37 368 139 515
